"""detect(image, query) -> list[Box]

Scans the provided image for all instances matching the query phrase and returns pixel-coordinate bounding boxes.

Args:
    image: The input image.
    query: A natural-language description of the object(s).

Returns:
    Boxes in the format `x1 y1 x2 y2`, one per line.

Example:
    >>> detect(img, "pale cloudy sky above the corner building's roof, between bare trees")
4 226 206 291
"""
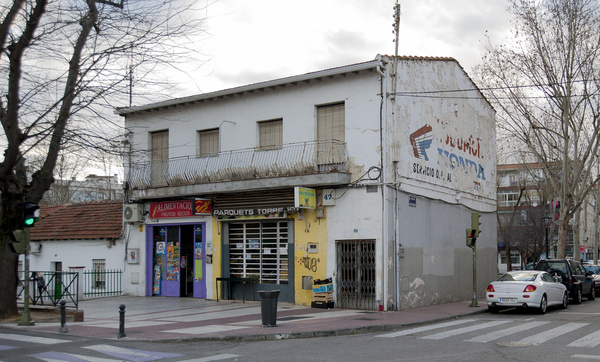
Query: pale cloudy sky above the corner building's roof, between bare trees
174 0 510 97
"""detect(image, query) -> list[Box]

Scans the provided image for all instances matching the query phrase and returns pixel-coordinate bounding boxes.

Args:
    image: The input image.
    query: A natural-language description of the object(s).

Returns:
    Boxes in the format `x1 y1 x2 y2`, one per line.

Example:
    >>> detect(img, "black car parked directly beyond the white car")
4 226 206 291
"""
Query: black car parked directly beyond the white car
535 259 596 304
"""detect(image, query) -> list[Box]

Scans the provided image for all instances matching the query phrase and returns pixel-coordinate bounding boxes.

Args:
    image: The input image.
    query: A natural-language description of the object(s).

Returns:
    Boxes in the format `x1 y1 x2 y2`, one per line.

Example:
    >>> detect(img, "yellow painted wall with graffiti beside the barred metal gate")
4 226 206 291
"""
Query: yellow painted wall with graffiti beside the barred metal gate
294 208 331 305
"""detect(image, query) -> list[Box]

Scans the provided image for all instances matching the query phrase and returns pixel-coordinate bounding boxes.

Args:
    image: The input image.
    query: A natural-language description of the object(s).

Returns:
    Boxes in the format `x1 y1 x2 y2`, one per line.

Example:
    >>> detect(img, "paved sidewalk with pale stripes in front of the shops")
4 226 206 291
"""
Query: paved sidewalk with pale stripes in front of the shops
2 297 487 341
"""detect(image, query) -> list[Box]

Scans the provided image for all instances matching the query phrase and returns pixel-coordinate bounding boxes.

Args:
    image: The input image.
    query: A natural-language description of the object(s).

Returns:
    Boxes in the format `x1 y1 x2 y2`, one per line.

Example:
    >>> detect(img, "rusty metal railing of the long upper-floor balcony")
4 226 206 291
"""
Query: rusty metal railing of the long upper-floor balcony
129 140 348 190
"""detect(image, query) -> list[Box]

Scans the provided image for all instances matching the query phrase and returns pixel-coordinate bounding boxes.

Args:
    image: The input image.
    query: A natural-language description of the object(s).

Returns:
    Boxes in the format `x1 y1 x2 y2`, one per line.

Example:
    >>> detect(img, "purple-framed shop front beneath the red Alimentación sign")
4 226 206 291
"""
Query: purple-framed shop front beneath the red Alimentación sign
146 223 206 298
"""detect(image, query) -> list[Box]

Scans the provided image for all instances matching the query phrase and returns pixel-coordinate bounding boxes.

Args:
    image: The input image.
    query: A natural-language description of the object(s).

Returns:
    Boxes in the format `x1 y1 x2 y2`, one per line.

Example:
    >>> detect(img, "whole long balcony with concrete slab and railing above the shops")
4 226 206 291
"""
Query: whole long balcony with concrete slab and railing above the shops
126 141 350 199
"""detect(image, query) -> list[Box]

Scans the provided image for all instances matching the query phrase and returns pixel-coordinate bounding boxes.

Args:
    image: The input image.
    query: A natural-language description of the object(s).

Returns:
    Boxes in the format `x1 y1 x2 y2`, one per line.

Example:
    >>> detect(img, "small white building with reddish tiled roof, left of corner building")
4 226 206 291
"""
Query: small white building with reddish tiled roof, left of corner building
29 200 129 296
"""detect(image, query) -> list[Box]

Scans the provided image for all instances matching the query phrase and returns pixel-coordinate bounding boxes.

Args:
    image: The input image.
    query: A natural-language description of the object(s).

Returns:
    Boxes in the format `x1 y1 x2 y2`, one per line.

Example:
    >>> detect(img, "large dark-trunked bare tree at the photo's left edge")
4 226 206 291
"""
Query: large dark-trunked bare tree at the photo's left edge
0 0 202 318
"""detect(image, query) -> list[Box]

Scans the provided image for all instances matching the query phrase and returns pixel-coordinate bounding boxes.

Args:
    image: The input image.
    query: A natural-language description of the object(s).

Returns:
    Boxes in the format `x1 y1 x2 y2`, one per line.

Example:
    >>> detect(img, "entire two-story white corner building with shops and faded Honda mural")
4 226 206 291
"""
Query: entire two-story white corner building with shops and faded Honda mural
118 56 496 310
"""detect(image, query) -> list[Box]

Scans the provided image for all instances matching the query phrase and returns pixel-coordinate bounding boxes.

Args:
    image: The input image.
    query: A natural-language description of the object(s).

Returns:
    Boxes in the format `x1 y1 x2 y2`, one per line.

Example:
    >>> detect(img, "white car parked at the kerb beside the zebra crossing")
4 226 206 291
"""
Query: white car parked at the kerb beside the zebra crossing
485 270 569 313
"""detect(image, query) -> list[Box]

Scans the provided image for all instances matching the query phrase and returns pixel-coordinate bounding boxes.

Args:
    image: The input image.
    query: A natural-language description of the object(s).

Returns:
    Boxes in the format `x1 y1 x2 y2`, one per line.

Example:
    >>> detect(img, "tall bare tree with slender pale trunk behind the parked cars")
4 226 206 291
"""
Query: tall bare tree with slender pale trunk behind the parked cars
476 0 600 258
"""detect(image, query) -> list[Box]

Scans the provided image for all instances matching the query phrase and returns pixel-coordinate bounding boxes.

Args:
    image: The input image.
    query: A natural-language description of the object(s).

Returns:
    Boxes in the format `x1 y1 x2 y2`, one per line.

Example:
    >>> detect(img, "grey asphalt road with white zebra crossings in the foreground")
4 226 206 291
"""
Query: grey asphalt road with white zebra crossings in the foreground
0 301 600 362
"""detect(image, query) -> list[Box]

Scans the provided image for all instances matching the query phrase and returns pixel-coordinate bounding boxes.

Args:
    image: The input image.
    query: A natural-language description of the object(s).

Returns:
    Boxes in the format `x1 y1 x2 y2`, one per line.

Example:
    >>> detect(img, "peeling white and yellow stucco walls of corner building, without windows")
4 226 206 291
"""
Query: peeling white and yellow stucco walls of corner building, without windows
118 56 496 310
